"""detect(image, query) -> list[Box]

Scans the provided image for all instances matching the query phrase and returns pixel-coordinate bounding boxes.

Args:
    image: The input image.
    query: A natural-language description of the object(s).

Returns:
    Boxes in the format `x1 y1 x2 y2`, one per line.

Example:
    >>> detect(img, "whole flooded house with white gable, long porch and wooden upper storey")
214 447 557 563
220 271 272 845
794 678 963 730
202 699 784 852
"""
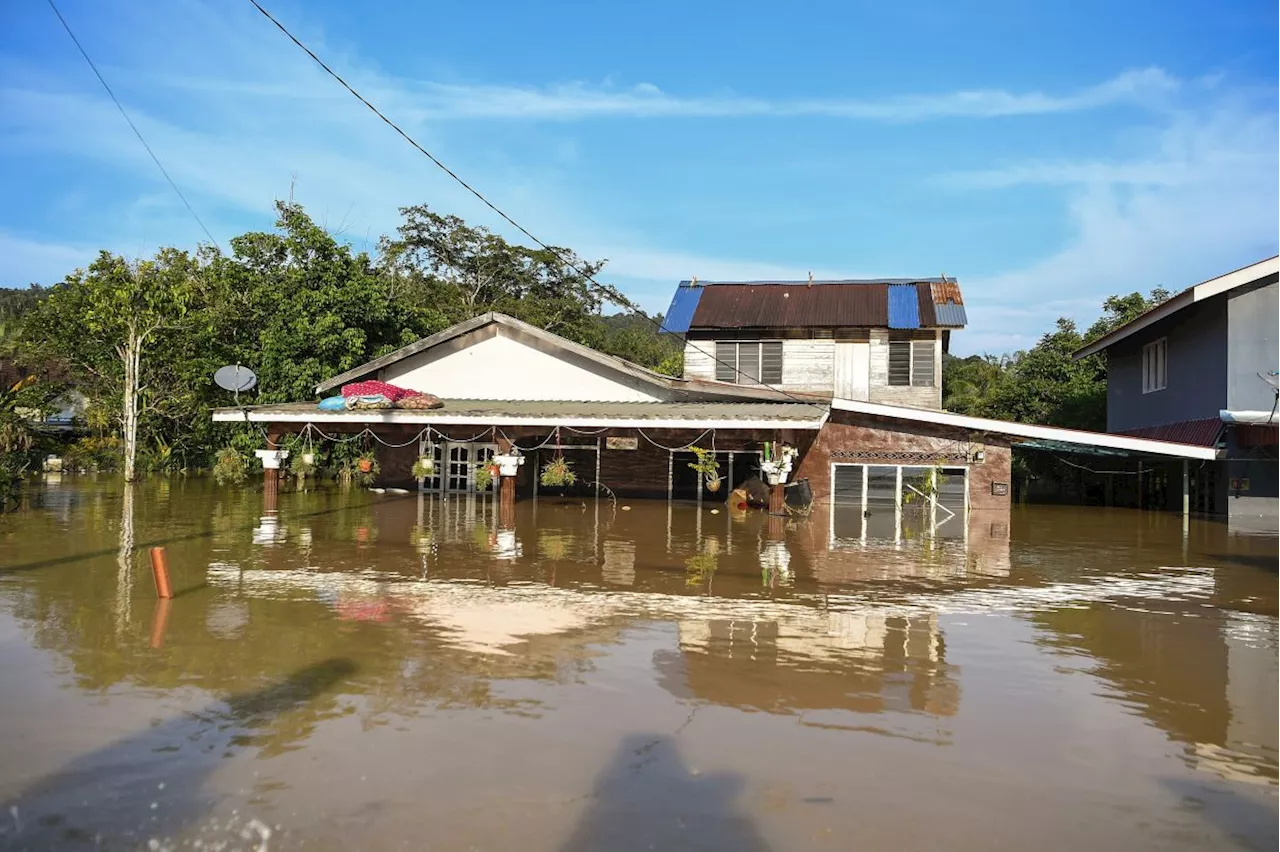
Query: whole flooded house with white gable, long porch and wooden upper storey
214 278 1215 539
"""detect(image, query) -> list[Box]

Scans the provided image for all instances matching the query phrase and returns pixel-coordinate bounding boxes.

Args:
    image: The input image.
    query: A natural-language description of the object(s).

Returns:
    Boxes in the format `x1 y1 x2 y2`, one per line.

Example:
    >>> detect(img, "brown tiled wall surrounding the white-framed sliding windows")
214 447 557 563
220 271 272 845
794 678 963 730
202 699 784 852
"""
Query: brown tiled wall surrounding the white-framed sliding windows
794 411 1012 512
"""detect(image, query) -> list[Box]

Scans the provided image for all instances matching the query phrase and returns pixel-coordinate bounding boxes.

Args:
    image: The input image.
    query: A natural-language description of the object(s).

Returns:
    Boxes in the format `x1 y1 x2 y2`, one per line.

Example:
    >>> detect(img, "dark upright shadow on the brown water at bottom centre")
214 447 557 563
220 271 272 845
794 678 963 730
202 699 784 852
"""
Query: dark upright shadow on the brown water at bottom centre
562 734 769 852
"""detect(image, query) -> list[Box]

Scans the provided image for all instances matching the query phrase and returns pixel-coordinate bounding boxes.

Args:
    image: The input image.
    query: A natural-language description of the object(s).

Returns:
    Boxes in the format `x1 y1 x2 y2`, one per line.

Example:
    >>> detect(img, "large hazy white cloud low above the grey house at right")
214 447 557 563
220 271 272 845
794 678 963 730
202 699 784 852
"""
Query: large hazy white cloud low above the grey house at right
955 100 1280 352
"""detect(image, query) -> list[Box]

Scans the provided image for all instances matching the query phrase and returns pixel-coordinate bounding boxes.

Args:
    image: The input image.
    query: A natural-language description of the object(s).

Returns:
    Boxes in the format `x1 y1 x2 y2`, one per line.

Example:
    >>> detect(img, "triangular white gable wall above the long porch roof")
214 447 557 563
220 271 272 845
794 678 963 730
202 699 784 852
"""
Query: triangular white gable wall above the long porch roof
379 333 659 402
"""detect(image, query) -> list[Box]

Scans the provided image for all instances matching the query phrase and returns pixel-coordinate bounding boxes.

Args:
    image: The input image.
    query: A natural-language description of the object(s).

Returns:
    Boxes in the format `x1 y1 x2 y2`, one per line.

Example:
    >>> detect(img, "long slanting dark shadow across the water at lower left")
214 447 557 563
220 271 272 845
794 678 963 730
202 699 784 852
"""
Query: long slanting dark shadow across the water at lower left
0 658 357 849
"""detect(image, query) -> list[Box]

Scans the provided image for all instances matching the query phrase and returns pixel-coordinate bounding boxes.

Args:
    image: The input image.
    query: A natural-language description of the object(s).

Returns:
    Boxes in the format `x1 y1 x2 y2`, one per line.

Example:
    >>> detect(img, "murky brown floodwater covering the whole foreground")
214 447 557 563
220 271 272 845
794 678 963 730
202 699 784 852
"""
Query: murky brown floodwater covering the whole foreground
0 477 1280 851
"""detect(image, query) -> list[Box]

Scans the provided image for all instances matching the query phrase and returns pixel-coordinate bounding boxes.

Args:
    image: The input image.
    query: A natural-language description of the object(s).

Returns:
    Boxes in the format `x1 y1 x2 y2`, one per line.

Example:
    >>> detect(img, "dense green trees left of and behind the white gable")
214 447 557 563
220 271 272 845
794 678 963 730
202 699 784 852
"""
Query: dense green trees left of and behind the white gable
0 202 681 472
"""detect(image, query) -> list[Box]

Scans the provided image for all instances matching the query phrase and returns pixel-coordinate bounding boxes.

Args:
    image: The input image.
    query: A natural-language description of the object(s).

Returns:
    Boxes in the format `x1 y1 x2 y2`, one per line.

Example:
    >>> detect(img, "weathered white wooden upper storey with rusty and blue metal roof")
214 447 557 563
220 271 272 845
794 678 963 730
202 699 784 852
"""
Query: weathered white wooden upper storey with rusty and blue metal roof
664 278 966 409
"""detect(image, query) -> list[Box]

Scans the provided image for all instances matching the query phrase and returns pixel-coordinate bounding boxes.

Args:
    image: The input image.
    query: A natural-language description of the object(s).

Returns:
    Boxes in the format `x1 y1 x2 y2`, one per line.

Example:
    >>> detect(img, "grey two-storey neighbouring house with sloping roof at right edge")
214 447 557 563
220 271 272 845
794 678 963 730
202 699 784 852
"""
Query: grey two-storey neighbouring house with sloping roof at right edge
1075 256 1280 523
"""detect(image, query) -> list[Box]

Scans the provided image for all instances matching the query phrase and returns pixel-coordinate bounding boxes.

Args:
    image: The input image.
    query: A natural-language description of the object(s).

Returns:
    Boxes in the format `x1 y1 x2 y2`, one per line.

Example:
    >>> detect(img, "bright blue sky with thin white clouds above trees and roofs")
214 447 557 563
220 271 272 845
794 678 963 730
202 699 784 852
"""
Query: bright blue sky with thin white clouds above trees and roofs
0 0 1280 353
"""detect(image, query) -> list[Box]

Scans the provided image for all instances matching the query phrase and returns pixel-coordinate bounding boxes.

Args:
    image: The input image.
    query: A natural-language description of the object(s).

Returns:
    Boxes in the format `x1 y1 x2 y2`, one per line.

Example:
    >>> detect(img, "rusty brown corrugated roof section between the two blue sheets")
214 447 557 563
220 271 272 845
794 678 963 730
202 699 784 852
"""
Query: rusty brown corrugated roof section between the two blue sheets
691 284 888 329
